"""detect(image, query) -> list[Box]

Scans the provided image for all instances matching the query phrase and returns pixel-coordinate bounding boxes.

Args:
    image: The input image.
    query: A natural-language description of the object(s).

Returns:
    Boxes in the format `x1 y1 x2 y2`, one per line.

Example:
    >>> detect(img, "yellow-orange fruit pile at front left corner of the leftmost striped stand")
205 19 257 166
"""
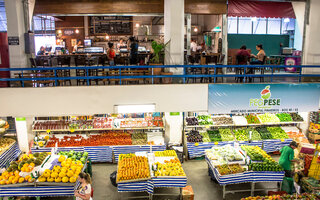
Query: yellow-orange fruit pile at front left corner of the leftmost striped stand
0 171 34 185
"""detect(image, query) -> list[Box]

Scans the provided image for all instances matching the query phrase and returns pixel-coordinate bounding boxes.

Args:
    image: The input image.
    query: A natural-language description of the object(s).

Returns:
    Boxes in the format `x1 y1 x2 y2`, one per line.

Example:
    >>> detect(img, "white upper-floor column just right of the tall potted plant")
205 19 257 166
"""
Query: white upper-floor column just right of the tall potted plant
164 0 184 74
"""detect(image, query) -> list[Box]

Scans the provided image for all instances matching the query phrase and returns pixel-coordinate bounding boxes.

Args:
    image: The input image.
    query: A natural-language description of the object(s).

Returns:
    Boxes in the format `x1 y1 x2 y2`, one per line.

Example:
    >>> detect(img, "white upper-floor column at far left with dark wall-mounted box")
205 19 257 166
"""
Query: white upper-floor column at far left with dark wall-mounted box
5 0 28 68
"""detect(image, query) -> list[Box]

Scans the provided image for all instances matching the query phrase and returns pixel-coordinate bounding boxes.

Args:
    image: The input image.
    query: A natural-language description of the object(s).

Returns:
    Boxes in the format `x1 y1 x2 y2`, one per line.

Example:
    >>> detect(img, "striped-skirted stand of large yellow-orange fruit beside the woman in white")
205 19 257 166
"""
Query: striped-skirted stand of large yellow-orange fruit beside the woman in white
0 151 88 199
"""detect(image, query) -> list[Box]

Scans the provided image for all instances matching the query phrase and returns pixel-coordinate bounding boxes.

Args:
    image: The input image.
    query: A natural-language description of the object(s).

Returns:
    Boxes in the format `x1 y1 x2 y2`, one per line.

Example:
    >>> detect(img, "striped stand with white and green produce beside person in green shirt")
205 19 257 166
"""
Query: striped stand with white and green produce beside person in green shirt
205 145 284 199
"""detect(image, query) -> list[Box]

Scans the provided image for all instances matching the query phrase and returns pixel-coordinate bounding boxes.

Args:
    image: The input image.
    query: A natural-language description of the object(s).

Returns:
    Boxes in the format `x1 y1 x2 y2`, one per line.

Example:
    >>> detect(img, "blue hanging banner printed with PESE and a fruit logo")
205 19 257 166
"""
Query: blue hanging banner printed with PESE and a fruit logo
208 83 320 114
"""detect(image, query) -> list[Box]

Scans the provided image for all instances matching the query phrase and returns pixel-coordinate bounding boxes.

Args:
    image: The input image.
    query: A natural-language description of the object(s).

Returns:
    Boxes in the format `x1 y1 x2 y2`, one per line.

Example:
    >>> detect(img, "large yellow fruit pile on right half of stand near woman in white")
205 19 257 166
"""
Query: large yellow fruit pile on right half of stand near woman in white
38 156 83 183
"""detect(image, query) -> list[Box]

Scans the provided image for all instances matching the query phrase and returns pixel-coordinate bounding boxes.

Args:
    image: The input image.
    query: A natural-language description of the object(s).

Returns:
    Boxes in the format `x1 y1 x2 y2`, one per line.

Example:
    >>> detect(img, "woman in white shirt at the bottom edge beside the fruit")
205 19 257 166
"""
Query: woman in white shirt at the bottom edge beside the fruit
74 172 92 200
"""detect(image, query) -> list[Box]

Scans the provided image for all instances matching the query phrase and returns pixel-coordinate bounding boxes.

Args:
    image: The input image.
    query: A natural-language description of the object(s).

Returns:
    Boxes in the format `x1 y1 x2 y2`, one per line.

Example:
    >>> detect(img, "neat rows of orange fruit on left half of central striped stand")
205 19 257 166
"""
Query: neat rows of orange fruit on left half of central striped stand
117 154 150 182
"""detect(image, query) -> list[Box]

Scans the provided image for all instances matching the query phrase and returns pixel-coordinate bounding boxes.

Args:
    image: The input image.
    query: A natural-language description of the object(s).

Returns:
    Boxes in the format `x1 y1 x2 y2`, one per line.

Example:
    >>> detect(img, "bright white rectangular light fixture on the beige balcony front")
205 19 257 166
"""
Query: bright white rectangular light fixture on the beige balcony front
114 104 156 113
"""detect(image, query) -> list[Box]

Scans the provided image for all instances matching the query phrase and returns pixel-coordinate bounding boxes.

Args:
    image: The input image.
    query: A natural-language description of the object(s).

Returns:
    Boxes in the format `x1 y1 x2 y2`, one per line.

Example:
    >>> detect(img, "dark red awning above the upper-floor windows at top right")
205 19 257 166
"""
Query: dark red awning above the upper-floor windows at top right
228 0 296 18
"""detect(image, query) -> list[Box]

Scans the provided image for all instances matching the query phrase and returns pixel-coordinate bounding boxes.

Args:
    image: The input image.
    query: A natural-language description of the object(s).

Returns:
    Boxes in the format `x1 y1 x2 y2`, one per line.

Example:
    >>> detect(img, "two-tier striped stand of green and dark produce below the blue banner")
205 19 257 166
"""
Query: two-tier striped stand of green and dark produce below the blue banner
184 113 304 159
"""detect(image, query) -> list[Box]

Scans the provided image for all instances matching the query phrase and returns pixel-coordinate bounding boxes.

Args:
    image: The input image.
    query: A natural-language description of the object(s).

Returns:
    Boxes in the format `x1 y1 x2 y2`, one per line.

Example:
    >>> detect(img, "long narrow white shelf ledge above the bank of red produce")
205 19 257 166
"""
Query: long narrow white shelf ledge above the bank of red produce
32 126 164 132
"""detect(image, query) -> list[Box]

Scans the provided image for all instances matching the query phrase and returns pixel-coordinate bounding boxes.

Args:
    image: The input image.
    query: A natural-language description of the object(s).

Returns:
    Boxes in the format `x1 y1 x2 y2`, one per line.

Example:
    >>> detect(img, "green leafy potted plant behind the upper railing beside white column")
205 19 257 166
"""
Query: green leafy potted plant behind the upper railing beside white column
150 40 172 83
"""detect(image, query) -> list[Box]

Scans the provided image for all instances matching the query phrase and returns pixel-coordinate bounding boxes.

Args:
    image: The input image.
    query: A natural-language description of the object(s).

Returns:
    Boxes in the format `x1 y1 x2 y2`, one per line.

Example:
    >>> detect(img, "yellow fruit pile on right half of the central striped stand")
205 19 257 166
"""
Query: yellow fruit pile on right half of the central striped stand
154 158 186 177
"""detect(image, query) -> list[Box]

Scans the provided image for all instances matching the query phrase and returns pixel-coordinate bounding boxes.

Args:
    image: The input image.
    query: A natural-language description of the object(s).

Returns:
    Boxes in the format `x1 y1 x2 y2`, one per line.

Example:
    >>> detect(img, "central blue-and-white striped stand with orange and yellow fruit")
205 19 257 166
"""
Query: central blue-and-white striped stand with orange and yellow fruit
117 150 187 199
